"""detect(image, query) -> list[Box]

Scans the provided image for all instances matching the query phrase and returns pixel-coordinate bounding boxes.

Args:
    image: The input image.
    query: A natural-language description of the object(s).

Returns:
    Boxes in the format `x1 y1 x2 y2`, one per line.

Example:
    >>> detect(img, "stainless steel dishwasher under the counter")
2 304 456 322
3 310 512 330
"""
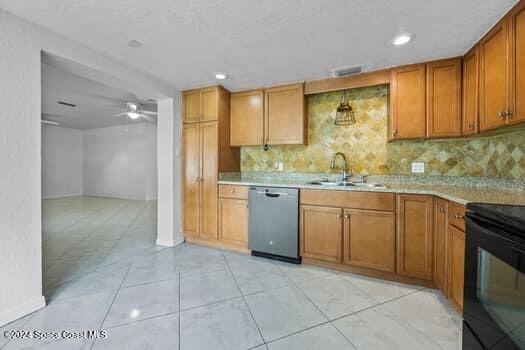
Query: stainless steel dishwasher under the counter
248 186 301 263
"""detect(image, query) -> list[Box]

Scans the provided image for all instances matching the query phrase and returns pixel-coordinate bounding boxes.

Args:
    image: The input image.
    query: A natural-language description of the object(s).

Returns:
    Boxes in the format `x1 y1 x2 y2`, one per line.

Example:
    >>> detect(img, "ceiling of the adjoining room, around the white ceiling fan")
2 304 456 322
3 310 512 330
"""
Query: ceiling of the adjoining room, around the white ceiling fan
42 64 157 129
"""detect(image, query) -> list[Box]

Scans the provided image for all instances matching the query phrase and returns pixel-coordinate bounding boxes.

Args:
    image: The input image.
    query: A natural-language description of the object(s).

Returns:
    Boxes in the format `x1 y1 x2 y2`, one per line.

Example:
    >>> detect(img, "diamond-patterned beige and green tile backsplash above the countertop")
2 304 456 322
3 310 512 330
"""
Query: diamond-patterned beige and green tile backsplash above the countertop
241 86 525 180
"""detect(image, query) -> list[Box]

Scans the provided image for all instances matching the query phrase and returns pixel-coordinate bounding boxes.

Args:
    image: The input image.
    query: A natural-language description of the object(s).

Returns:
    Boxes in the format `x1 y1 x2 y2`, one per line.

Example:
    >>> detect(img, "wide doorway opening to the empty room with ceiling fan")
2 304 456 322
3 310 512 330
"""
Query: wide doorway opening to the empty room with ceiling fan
42 55 158 301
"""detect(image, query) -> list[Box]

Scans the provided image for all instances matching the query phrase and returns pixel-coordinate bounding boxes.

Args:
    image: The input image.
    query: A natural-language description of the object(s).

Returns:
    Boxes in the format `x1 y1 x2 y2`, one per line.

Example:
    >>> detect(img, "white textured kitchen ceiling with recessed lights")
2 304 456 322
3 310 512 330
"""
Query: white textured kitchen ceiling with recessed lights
0 0 517 90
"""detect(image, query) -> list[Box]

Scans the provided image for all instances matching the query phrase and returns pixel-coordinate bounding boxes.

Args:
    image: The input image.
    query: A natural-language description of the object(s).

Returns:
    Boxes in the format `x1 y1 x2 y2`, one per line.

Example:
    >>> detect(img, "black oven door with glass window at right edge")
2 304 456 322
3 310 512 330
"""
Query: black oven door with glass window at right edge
463 217 525 349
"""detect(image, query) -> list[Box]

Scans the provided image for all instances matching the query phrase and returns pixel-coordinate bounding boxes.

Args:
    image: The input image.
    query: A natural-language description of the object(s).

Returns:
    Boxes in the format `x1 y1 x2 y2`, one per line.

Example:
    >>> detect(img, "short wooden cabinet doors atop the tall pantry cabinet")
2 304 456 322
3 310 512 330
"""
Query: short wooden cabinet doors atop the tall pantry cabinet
182 86 220 123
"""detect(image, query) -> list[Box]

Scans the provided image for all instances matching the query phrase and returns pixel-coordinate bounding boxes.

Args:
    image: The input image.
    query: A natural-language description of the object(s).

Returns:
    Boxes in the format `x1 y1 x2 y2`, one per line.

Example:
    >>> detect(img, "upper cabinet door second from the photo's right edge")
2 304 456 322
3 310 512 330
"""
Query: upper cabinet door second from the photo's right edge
479 21 509 131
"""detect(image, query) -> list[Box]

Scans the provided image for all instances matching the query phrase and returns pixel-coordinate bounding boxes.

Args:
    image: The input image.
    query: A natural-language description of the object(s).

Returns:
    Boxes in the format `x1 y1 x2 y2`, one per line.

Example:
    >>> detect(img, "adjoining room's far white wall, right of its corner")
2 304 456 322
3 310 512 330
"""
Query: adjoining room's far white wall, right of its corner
84 123 157 200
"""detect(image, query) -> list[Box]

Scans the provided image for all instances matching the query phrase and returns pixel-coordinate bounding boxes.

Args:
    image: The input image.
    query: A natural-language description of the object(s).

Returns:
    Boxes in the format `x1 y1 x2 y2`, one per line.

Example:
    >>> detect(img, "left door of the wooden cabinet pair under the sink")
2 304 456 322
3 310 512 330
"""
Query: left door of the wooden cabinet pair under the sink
300 205 343 262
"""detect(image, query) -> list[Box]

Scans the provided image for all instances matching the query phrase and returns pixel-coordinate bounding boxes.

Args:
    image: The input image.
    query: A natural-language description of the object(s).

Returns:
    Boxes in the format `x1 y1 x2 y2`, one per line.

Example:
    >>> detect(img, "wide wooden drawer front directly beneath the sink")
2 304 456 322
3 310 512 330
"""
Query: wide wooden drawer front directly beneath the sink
301 190 396 211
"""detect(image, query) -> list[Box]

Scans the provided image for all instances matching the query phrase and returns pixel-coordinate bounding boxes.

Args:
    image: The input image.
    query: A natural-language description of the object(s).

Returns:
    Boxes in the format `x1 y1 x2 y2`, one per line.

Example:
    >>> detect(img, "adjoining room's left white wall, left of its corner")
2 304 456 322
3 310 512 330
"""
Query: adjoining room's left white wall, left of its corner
42 124 84 198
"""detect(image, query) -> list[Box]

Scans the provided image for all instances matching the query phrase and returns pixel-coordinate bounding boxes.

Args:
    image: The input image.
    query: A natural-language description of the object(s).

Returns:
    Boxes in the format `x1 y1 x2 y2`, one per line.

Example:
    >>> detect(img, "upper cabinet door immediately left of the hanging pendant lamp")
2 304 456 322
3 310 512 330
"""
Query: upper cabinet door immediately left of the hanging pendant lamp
264 84 306 145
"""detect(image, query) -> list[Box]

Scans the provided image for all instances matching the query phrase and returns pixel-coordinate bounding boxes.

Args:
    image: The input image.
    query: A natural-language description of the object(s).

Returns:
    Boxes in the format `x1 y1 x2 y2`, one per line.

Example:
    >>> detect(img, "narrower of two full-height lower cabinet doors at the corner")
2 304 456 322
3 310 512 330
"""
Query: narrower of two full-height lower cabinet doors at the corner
434 199 448 295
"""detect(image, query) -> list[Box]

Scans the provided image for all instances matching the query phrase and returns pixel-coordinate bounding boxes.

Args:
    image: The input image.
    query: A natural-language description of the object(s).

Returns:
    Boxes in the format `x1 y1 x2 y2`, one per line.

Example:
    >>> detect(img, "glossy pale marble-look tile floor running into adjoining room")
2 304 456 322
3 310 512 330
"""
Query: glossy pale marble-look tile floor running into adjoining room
0 197 461 350
